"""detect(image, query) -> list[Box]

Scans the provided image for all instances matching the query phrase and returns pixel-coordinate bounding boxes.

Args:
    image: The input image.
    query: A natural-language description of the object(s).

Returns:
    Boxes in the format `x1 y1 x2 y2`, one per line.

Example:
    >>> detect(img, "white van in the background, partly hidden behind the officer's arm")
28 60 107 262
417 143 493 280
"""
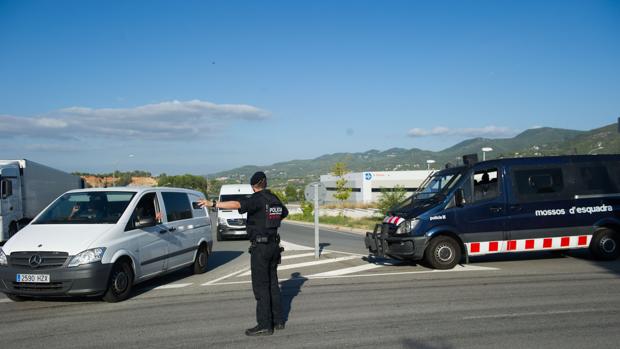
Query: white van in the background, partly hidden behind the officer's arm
217 184 254 241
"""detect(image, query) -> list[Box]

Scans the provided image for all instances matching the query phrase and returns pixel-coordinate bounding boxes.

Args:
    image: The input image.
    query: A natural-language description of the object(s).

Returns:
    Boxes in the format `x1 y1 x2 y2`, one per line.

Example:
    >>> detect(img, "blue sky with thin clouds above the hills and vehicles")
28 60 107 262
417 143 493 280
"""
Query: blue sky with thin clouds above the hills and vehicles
0 0 620 174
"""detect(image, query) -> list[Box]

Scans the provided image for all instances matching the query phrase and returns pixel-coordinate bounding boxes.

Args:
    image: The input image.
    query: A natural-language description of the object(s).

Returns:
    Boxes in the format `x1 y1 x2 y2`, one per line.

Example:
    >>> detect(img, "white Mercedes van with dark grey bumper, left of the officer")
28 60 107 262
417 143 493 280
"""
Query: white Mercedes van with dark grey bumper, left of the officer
0 187 213 302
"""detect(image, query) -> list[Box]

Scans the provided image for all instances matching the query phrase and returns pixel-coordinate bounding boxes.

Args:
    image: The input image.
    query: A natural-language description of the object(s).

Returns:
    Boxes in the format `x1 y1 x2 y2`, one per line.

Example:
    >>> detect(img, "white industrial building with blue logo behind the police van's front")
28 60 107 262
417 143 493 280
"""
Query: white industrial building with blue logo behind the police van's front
321 170 433 203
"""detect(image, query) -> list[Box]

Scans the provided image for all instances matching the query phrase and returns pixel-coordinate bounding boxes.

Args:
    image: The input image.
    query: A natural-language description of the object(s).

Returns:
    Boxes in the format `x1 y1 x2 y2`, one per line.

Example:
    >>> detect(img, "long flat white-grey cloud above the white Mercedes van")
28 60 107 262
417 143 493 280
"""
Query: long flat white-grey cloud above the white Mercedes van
0 100 270 140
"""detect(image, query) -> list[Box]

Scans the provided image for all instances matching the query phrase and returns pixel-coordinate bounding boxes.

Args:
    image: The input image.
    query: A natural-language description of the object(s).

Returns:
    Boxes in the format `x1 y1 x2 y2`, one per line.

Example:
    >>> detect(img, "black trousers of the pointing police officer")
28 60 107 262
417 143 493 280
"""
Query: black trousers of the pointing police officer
251 242 282 328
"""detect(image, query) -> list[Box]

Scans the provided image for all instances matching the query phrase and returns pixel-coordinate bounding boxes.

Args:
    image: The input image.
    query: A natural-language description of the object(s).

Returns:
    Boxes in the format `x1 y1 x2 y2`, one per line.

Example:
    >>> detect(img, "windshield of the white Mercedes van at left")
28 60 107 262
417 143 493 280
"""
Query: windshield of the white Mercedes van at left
32 191 136 224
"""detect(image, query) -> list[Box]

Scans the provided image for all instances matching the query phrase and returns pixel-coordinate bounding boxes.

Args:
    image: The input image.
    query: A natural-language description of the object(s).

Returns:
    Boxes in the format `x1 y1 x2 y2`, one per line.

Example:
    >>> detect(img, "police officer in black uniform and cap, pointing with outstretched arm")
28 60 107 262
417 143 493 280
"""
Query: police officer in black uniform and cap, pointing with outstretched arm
200 171 288 336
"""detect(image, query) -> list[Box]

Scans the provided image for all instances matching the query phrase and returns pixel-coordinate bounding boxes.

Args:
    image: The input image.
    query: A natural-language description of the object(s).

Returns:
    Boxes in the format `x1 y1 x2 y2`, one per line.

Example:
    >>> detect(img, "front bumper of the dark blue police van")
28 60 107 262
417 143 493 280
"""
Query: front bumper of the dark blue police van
364 231 428 260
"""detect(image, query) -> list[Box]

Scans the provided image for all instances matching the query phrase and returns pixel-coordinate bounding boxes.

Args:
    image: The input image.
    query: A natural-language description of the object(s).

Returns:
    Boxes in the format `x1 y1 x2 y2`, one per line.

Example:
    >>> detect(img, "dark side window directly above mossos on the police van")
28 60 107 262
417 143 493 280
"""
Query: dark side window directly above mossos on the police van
513 167 566 201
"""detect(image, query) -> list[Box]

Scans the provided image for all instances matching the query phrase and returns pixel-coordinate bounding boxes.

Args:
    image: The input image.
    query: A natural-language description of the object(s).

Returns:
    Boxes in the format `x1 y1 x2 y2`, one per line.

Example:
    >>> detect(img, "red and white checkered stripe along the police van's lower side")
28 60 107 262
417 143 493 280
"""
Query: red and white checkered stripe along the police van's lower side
465 235 592 256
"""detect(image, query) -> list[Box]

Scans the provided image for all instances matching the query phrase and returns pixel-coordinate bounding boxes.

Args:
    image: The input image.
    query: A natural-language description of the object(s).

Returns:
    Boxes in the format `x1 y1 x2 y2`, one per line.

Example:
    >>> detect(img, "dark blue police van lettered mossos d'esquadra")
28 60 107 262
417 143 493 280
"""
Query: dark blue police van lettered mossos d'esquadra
365 155 620 269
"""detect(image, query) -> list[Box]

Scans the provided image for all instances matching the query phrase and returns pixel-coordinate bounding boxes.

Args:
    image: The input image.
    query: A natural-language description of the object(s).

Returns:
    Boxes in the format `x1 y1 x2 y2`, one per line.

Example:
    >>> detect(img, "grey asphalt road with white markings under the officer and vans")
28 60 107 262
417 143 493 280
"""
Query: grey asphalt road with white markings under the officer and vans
0 224 620 349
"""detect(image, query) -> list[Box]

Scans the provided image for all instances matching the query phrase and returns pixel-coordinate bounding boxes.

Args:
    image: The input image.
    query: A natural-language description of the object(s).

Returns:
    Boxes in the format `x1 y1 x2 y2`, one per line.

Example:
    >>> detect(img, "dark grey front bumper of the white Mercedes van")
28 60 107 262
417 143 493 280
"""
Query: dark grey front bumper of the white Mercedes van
0 262 113 297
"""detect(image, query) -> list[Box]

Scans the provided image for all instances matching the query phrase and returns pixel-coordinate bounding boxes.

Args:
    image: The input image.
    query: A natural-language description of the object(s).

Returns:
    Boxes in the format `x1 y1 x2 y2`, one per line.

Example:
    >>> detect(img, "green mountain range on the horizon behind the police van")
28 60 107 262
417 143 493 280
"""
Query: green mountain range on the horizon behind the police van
208 124 620 183
